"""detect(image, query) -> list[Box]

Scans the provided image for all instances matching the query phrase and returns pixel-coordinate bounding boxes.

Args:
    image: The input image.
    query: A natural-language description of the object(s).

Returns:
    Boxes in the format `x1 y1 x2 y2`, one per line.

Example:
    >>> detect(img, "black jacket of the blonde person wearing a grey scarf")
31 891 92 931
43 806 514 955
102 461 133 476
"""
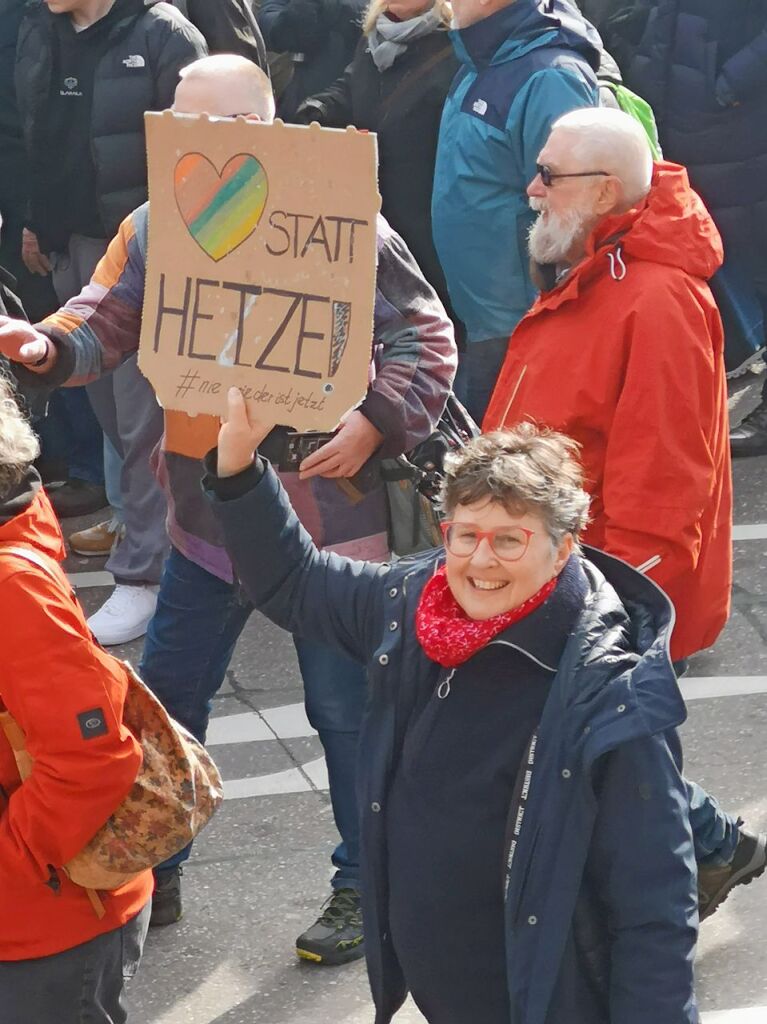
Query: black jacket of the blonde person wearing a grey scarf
297 31 458 335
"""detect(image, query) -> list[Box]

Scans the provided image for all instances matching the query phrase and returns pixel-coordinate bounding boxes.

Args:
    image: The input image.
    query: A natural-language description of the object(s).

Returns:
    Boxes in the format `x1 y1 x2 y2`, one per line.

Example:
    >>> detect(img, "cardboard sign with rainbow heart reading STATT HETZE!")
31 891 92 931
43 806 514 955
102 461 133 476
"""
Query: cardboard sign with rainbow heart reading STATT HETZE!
138 111 380 430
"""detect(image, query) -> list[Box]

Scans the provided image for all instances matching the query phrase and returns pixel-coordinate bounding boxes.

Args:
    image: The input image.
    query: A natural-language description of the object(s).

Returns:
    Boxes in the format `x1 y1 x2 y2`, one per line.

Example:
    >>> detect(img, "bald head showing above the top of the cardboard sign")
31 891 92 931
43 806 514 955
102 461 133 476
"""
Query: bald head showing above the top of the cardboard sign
173 53 274 123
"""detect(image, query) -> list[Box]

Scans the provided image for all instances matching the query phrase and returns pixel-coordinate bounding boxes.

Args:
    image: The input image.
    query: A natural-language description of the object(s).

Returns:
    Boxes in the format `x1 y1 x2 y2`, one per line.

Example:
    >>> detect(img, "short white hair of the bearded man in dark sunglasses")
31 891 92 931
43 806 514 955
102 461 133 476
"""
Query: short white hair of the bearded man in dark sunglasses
551 106 652 206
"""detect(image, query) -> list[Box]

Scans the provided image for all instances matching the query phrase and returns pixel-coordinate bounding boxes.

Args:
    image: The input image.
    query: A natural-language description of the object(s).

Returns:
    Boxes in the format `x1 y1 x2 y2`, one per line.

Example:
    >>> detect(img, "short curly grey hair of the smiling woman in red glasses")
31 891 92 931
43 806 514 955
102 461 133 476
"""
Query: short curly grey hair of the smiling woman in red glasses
440 423 589 545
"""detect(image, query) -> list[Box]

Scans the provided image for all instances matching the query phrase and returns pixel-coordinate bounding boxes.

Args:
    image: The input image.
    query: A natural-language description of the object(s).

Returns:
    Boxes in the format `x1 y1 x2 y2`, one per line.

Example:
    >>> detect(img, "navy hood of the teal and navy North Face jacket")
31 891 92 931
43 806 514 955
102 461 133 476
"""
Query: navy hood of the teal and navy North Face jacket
450 0 602 72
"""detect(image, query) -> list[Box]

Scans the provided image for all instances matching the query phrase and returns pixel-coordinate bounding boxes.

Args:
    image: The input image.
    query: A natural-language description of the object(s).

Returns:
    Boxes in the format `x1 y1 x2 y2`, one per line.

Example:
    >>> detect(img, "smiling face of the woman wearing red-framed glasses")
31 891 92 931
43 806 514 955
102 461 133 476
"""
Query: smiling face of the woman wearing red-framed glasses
445 499 572 621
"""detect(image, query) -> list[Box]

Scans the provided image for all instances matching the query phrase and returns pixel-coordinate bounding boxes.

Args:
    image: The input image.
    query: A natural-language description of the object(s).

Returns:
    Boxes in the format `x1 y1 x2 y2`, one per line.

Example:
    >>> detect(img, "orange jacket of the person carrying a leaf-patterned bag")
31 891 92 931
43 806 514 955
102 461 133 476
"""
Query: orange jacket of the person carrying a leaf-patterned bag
0 490 152 954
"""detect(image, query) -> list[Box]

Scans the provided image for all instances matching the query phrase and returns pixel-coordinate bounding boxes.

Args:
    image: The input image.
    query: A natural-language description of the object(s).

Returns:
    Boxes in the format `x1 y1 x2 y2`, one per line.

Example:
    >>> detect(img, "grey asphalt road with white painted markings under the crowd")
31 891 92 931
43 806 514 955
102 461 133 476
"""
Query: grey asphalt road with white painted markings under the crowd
59 374 767 1024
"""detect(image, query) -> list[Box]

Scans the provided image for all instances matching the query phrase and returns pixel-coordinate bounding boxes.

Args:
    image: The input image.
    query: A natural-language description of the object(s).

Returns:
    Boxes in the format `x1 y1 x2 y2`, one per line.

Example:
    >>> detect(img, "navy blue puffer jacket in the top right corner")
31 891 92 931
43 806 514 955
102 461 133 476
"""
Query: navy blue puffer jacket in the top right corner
625 0 767 291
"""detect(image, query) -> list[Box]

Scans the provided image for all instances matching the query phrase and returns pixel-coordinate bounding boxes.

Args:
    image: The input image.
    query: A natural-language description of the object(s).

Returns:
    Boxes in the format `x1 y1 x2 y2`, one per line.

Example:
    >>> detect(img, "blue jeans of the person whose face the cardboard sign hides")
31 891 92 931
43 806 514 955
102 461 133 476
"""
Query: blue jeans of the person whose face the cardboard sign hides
139 548 367 889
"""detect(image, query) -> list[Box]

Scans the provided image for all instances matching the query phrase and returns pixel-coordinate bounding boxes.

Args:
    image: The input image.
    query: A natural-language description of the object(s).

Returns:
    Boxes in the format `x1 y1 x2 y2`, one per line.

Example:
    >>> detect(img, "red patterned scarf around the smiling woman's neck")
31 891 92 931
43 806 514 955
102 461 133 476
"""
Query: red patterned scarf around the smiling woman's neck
416 565 557 669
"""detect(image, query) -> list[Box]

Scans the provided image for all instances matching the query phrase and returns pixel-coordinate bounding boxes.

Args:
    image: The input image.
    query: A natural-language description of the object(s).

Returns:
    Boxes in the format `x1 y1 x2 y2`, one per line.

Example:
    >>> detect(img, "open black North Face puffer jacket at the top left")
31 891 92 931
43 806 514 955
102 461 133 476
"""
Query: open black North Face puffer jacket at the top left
15 0 208 248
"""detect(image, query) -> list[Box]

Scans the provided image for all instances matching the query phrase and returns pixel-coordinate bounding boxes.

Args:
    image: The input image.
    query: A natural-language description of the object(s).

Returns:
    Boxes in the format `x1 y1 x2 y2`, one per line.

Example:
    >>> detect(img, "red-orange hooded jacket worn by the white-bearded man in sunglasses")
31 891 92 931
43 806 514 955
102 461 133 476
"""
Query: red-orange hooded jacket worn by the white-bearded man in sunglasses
483 163 732 658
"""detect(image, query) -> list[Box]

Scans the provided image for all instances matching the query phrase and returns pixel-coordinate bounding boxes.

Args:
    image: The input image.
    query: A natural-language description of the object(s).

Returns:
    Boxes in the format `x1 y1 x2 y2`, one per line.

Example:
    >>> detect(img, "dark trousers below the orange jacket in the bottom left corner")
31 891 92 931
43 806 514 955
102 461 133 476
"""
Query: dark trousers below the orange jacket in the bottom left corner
0 903 150 1024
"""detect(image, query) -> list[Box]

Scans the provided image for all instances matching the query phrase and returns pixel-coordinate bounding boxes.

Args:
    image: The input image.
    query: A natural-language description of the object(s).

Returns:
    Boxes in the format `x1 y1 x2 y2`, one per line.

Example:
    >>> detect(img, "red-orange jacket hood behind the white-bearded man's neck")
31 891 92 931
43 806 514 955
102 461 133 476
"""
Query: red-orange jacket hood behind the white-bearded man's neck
588 163 724 281
